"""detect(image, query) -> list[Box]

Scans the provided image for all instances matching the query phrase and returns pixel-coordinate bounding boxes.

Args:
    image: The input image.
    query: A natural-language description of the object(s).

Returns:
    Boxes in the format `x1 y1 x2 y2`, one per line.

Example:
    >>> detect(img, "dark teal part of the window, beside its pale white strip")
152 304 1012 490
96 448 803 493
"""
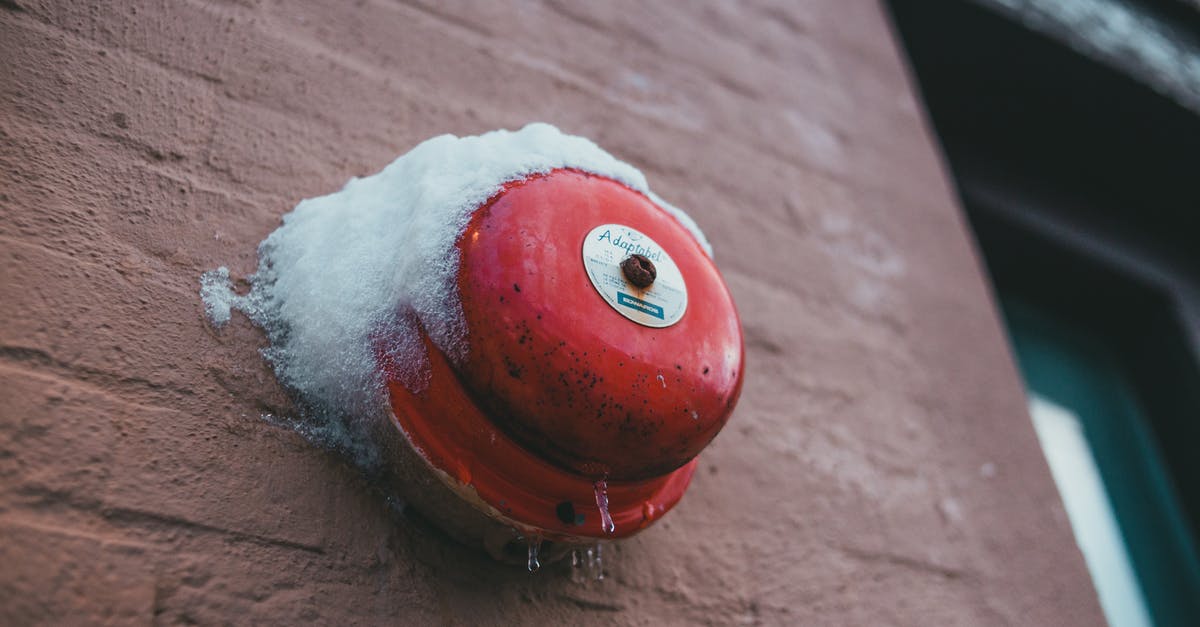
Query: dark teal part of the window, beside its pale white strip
1002 297 1200 626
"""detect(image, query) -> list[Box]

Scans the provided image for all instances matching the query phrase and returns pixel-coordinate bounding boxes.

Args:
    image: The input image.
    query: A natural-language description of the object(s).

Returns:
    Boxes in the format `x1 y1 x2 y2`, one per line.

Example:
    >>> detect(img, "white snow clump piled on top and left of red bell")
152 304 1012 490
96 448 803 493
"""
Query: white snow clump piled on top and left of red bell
200 124 712 466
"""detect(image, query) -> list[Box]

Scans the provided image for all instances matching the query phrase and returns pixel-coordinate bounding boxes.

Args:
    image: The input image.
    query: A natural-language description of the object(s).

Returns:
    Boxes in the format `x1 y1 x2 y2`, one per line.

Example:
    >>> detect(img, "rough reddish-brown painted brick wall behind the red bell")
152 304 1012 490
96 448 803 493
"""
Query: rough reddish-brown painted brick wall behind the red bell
0 0 1103 625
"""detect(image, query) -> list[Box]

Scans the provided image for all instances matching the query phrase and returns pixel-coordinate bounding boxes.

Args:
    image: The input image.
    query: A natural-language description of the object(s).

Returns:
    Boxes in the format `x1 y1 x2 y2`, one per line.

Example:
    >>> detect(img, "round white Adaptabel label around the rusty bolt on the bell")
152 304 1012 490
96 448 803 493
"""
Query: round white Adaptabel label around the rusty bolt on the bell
583 225 688 327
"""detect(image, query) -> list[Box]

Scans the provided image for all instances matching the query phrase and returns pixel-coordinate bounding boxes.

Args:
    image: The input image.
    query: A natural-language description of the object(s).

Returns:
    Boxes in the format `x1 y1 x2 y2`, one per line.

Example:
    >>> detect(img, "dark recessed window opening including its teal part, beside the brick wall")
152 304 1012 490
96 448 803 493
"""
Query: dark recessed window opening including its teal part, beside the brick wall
888 0 1200 625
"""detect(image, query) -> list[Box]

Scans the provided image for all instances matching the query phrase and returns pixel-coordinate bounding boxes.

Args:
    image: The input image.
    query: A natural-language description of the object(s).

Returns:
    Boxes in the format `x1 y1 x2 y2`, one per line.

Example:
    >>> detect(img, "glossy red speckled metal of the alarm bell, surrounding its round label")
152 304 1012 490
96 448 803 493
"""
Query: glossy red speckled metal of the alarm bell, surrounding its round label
385 169 744 538
